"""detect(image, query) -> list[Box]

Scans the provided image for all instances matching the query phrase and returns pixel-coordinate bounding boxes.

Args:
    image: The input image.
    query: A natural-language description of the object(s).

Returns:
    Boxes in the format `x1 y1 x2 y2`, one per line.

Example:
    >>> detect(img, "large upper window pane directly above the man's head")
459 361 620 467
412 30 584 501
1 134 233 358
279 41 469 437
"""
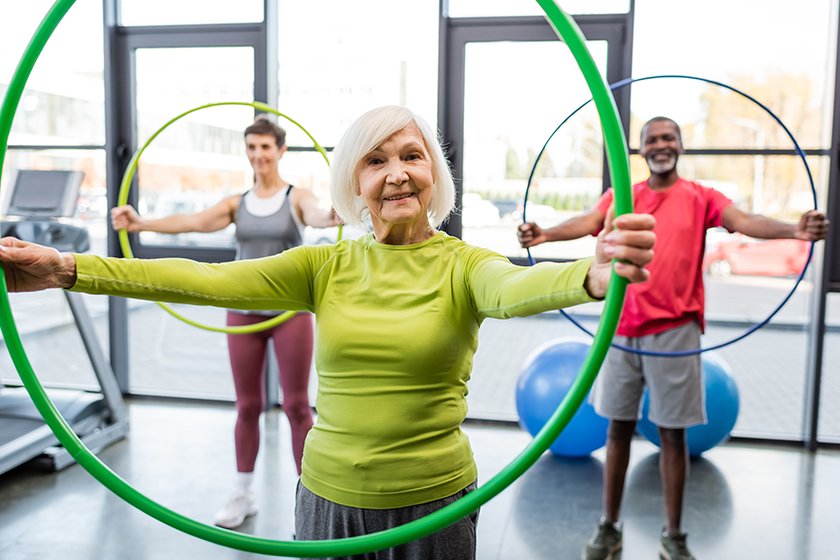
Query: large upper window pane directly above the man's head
631 0 837 153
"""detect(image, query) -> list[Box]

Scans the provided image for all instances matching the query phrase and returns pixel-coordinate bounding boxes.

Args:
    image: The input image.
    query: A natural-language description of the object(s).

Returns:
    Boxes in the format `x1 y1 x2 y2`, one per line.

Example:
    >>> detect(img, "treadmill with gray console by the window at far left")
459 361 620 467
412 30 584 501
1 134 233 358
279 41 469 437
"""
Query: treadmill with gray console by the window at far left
0 170 129 474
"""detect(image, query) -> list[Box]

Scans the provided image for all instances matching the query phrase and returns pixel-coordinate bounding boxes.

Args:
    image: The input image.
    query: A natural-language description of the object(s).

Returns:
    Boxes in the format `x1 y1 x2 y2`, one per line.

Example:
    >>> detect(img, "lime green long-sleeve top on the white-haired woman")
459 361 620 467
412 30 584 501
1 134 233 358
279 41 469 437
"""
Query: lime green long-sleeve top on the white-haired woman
72 233 592 509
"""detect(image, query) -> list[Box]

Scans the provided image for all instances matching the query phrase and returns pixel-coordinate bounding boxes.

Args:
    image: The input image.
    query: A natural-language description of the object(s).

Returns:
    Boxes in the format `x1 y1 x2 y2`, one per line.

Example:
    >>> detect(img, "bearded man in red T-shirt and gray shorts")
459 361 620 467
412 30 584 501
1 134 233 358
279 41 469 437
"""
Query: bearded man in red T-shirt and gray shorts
517 117 828 560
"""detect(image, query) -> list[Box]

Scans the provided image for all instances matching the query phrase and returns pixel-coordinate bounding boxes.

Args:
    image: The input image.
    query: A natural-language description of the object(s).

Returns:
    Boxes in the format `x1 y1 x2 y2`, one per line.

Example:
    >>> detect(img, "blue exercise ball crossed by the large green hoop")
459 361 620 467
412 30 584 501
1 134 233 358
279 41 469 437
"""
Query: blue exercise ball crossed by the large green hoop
516 338 609 457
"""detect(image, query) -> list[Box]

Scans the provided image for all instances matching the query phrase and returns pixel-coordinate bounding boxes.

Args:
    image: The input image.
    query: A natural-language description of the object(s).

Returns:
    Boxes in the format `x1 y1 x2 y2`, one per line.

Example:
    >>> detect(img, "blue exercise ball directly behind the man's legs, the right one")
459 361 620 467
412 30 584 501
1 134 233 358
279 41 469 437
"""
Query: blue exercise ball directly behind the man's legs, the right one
638 352 741 457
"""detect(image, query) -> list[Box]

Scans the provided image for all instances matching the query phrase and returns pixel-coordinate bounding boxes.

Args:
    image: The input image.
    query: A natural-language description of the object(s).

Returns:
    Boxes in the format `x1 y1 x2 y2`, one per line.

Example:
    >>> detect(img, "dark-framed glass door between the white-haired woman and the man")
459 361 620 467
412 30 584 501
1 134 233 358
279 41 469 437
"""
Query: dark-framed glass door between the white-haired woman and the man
438 14 632 421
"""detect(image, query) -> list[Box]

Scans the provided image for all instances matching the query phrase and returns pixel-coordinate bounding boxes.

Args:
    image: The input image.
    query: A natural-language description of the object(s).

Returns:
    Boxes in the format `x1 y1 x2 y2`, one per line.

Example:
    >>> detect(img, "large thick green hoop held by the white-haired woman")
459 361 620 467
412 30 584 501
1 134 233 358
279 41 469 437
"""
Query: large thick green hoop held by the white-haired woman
0 0 633 558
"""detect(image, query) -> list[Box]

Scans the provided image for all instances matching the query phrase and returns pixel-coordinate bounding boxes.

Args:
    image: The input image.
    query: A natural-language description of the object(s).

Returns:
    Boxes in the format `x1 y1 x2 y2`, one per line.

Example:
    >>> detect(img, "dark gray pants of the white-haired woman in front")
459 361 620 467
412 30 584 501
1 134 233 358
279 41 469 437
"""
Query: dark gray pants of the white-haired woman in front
295 480 478 560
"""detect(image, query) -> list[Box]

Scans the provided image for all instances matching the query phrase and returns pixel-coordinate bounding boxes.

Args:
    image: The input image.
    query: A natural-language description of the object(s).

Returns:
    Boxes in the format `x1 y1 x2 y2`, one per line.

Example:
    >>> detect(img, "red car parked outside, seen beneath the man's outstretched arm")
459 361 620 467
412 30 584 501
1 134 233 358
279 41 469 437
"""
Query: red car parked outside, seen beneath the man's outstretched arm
703 233 811 278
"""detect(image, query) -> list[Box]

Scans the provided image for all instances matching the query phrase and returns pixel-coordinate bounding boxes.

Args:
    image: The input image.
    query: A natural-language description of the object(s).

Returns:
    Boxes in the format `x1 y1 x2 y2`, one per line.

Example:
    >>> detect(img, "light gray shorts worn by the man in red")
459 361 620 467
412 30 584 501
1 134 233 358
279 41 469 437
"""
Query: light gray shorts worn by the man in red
589 321 706 428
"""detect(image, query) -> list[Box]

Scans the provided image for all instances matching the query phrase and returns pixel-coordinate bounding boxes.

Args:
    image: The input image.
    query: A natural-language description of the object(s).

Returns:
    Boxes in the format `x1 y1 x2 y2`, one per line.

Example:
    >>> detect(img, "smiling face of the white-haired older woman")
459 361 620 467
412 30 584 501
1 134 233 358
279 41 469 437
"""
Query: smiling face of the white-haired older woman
356 123 435 245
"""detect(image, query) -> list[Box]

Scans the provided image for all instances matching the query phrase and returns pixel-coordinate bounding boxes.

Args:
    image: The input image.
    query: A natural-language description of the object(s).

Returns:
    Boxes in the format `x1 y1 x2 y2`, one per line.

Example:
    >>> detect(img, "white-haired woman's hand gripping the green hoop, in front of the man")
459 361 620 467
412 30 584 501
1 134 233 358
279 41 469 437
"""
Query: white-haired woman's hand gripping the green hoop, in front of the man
584 208 656 299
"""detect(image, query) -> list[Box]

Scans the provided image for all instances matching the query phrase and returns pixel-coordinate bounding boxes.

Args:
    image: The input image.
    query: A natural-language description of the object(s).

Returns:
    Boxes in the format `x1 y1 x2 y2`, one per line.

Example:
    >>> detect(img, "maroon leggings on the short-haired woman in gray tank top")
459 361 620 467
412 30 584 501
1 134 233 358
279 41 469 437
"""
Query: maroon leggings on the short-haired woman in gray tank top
227 311 313 474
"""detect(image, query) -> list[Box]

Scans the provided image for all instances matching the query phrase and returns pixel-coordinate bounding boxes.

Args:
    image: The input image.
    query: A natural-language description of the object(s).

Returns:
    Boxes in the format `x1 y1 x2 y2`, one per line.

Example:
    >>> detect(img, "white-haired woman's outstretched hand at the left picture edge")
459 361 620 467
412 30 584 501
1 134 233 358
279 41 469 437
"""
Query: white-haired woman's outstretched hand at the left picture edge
0 237 76 292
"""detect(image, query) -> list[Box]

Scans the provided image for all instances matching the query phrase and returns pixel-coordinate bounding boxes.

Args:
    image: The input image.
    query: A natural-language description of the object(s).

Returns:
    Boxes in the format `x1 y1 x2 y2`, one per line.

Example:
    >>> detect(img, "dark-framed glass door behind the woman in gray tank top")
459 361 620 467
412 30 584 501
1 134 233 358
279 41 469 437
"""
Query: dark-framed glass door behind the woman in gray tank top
106 14 276 400
